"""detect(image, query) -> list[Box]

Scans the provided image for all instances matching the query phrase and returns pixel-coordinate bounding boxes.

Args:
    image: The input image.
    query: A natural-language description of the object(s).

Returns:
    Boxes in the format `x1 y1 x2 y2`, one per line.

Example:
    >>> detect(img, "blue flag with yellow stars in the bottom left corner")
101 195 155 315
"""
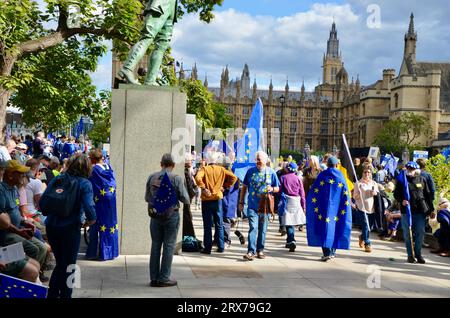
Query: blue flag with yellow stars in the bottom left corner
0 274 47 299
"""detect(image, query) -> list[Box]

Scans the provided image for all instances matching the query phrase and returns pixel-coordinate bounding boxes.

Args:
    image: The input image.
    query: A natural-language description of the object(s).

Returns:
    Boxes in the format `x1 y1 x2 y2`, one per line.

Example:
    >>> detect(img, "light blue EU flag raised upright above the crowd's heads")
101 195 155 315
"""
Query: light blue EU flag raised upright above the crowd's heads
233 98 264 181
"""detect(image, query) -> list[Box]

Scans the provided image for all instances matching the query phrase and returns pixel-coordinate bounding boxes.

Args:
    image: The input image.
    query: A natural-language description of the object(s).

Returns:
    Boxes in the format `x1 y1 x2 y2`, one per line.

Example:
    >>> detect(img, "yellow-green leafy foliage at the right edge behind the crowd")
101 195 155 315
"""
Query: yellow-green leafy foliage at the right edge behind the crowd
426 154 450 204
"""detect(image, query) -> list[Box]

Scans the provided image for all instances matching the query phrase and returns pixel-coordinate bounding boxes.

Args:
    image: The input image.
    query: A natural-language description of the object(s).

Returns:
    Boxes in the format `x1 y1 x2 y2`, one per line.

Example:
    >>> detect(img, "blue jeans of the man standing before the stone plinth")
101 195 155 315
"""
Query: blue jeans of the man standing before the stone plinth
150 212 180 282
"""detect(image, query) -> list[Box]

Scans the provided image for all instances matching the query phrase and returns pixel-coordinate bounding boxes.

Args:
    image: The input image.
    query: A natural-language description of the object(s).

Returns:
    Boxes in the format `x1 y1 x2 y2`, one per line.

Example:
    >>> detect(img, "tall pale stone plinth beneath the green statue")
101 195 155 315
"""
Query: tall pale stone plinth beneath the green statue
110 85 186 255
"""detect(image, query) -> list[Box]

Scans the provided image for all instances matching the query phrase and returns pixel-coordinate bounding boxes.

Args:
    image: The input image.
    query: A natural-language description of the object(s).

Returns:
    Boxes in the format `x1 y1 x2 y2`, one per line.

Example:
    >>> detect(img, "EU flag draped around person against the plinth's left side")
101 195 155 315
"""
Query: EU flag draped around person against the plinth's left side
86 164 119 260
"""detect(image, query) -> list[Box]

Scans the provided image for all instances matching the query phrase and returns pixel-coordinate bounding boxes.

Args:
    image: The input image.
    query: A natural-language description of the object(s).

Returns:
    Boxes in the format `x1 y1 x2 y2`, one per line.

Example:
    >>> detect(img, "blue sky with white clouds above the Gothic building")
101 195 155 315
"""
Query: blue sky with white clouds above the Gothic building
92 0 450 90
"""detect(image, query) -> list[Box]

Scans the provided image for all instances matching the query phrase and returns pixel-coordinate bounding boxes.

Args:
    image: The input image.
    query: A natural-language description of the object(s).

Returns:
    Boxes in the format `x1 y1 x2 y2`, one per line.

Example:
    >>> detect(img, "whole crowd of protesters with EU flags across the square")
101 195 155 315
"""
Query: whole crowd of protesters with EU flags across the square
0 128 450 298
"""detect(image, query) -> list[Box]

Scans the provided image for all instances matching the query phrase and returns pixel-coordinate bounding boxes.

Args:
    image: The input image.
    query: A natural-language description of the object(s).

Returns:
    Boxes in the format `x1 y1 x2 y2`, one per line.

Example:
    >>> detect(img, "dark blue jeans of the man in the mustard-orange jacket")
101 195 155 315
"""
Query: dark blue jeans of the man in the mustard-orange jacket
202 200 225 252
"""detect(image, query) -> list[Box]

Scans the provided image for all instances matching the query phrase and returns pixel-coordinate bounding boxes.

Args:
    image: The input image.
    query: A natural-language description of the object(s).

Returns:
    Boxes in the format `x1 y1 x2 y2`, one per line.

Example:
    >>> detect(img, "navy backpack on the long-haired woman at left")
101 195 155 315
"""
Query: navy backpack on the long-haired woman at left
40 173 79 218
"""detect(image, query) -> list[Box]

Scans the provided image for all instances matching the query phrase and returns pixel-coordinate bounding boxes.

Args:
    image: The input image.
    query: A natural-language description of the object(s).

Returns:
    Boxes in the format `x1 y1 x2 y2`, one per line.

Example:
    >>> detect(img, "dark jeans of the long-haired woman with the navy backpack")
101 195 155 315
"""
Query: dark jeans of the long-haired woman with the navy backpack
46 224 81 298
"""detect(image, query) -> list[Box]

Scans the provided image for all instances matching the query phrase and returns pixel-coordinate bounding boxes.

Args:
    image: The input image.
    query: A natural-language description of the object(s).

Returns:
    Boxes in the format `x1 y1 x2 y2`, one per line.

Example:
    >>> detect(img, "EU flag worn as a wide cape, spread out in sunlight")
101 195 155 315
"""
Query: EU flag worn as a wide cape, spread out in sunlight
306 168 352 249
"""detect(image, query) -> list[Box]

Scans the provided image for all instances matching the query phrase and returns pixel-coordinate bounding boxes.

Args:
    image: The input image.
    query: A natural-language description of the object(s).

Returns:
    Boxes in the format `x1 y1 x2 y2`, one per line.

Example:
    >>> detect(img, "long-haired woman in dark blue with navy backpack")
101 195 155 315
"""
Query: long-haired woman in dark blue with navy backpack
39 155 96 298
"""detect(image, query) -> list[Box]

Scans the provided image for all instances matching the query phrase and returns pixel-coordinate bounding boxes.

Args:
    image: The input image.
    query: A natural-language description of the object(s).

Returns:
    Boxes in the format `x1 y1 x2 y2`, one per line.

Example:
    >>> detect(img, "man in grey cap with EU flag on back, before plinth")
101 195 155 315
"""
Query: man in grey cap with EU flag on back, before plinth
145 153 190 287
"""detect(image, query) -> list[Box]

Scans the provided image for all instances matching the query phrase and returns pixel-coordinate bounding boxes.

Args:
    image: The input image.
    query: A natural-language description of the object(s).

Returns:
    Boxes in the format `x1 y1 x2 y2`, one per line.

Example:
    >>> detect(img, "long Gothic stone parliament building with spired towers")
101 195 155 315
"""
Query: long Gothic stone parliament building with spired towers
186 14 450 151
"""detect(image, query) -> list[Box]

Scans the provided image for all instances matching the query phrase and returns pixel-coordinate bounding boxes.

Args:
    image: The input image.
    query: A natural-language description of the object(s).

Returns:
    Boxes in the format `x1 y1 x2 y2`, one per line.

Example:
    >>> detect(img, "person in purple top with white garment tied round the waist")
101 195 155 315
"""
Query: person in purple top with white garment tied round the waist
278 161 306 252
